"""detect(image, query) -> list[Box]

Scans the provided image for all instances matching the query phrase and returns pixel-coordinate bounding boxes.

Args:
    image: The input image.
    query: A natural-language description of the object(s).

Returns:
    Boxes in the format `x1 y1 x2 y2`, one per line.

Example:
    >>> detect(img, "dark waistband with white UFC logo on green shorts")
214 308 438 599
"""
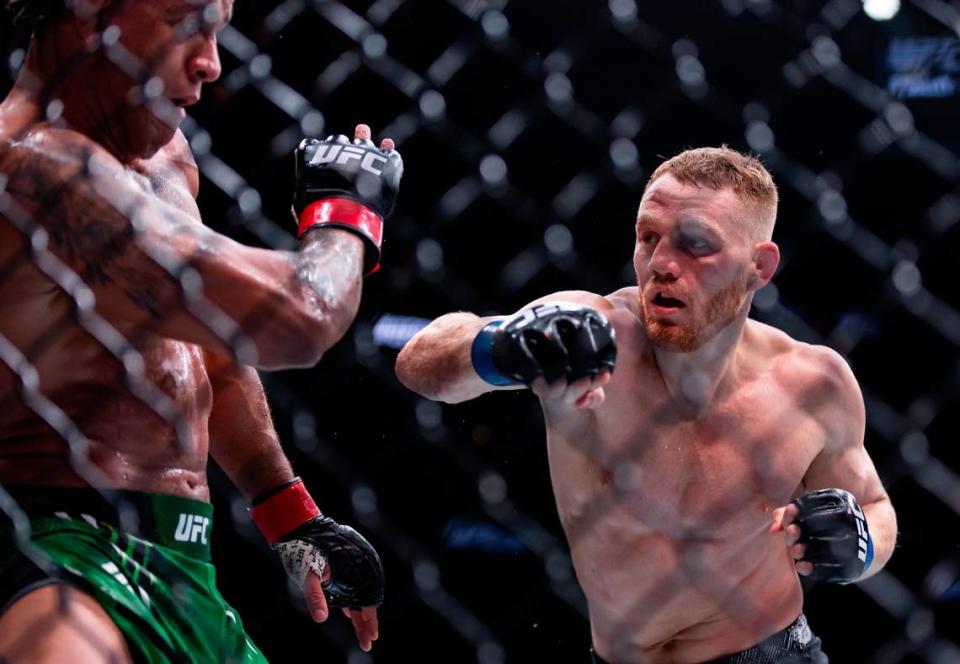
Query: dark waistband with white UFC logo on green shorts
0 484 213 561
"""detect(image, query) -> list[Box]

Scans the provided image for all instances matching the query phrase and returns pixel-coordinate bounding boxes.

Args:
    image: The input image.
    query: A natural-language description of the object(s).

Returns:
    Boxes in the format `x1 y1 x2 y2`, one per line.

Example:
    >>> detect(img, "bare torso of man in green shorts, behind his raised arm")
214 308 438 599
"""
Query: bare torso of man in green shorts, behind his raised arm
0 103 212 499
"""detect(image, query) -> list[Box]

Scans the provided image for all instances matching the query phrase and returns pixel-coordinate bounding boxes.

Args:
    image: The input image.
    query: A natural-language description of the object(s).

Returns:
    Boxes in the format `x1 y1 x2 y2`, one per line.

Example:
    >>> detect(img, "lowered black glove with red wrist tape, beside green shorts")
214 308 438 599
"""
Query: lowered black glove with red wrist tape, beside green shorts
250 477 383 609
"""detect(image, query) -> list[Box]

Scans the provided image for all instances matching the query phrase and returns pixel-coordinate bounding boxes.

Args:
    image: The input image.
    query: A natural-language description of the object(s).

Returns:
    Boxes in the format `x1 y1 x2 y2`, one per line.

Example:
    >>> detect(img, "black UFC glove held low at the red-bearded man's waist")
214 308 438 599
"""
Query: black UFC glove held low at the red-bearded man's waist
793 489 873 583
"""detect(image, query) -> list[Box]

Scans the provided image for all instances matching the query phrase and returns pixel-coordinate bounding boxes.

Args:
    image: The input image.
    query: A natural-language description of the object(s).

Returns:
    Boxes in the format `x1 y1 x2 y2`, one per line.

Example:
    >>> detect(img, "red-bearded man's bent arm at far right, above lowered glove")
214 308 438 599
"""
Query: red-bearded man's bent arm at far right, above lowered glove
803 348 897 580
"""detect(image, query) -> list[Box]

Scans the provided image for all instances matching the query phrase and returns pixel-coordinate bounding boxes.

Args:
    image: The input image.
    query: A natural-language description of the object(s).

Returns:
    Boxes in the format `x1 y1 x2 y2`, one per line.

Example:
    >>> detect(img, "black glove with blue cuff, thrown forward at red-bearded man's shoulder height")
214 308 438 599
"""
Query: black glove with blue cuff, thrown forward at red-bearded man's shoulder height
471 302 617 385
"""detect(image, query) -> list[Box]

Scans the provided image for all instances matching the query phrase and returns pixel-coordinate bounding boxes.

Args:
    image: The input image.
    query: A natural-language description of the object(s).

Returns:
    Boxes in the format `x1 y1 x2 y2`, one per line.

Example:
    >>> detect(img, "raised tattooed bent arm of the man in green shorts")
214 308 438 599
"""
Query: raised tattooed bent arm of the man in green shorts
0 129 363 368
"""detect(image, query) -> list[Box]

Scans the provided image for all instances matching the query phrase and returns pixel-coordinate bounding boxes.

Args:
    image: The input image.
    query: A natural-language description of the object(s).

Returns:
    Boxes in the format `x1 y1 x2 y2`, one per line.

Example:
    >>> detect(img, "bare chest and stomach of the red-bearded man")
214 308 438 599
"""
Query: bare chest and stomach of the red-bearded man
545 289 826 663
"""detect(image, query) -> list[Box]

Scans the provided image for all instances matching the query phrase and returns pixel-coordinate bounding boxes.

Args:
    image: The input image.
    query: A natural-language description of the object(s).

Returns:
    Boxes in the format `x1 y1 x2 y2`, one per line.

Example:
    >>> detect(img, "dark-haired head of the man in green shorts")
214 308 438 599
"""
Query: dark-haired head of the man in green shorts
5 0 233 158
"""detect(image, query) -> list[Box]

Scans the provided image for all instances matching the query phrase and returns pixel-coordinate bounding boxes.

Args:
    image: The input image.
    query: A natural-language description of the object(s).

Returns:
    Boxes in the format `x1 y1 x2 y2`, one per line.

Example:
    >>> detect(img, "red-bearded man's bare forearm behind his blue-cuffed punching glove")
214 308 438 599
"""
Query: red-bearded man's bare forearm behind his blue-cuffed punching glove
396 312 510 403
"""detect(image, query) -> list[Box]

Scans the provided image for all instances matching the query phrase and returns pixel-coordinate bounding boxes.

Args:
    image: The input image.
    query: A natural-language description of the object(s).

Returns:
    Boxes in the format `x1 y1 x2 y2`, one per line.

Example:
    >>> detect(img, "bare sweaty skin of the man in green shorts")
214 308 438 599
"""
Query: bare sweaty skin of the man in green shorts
0 0 382 662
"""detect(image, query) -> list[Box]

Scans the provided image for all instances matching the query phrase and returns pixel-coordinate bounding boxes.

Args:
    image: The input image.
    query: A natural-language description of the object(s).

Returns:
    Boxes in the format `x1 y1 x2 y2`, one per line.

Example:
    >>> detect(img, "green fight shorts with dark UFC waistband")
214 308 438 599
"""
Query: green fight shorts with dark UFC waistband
0 485 267 664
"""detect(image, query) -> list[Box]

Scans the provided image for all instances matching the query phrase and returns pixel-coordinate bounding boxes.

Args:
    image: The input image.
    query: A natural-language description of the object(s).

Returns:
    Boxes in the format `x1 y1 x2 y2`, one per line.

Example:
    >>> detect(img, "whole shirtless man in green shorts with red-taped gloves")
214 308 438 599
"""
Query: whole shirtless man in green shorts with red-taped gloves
0 0 402 663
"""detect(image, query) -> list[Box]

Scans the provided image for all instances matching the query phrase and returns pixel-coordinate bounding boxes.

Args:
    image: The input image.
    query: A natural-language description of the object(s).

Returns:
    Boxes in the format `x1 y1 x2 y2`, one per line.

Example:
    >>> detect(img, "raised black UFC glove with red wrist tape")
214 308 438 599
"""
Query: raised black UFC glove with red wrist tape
293 128 403 274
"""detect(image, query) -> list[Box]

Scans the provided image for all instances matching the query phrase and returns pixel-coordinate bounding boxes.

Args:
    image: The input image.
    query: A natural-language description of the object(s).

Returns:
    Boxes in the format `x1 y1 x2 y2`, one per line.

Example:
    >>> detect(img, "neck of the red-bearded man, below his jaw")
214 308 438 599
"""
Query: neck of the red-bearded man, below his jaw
653 312 747 416
